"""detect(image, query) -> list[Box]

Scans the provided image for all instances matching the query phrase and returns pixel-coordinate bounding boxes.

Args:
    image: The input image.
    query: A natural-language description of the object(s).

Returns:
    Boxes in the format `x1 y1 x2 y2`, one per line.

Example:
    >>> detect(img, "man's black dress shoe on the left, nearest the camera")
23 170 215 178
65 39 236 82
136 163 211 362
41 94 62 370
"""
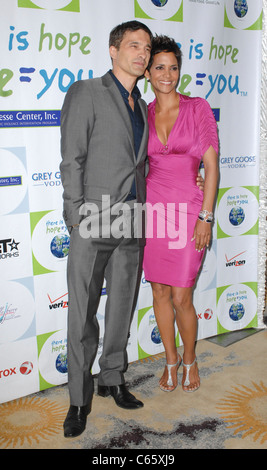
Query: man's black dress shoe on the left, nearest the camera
63 405 91 437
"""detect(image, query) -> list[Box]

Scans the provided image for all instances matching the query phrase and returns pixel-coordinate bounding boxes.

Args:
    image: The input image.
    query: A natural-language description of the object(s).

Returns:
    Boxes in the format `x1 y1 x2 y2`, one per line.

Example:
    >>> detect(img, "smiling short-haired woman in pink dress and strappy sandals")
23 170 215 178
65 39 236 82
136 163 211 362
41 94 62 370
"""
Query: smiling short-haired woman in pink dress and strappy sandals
144 36 218 392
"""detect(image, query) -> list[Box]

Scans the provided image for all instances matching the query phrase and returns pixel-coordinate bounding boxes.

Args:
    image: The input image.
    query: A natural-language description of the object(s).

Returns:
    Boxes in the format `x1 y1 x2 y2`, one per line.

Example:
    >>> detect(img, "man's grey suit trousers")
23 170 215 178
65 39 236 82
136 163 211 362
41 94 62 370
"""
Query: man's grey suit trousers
67 207 143 406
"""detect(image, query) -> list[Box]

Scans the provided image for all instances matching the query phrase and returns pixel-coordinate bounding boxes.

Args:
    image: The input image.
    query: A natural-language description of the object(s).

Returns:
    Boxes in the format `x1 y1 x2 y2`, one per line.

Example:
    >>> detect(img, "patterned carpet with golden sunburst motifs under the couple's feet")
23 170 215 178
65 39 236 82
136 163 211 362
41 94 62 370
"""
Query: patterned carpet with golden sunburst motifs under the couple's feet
0 330 267 452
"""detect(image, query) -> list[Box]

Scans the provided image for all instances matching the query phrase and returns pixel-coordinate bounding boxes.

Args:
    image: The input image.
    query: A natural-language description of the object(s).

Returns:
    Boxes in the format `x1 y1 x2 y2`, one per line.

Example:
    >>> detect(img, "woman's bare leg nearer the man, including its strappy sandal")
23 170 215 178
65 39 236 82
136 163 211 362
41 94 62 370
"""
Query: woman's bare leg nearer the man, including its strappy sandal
151 282 180 391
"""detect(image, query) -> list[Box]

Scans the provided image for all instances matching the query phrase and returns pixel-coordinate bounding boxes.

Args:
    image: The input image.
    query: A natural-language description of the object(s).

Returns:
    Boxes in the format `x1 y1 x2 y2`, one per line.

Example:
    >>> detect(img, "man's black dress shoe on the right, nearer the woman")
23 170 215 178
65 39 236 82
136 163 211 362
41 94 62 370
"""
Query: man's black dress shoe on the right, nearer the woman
98 384 144 410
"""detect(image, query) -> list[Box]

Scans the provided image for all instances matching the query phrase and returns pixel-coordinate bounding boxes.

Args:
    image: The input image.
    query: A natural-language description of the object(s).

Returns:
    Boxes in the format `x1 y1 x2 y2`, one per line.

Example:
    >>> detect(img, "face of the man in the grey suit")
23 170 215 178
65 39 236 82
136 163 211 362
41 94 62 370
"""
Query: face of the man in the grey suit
110 29 151 79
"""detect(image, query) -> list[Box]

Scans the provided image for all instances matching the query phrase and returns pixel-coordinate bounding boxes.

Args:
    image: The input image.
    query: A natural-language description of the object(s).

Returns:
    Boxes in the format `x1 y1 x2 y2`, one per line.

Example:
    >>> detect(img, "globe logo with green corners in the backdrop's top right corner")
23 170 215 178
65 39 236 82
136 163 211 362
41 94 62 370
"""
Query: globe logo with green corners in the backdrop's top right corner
224 0 262 30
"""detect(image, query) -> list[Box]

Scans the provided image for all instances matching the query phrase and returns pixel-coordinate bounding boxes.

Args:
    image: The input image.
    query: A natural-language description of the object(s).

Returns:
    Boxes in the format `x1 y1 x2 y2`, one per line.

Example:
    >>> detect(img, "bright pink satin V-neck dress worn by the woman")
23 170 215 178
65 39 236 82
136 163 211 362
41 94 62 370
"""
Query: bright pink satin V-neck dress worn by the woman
143 95 218 287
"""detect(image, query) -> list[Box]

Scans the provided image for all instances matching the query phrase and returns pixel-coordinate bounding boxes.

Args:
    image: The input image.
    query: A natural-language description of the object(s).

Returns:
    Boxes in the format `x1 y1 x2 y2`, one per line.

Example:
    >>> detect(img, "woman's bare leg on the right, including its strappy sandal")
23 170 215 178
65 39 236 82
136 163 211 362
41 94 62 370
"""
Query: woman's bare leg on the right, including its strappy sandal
172 287 200 391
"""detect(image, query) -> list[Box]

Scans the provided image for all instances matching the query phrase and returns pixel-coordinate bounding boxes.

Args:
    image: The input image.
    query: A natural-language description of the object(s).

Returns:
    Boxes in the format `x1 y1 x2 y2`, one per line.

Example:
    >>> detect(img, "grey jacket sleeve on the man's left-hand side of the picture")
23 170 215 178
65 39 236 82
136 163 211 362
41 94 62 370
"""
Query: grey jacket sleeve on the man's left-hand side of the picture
60 80 94 227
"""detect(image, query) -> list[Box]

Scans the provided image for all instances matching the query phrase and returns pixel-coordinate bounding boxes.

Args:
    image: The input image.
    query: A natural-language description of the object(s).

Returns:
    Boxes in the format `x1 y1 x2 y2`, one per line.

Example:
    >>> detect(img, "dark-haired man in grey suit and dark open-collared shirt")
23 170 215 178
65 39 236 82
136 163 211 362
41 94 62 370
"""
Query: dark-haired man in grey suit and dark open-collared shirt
60 21 152 437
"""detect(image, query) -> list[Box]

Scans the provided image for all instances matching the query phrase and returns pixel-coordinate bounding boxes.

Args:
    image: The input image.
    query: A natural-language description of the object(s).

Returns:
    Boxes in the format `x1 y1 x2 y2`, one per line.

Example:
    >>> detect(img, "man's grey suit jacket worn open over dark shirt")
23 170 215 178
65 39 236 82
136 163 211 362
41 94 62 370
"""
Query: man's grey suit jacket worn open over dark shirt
60 73 148 242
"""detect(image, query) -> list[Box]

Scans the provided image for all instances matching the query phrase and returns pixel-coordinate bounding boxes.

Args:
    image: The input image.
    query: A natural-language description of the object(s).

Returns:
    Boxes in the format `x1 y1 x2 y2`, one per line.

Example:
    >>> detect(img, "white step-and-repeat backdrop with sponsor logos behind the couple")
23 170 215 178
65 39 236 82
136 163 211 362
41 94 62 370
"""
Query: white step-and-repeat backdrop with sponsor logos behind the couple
0 0 262 402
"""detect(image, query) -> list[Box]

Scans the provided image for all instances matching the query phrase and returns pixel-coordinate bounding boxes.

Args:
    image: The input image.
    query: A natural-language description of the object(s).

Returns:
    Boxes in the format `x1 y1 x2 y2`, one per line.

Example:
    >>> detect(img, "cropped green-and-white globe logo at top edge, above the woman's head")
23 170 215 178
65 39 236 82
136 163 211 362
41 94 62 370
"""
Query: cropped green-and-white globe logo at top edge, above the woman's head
134 0 183 22
